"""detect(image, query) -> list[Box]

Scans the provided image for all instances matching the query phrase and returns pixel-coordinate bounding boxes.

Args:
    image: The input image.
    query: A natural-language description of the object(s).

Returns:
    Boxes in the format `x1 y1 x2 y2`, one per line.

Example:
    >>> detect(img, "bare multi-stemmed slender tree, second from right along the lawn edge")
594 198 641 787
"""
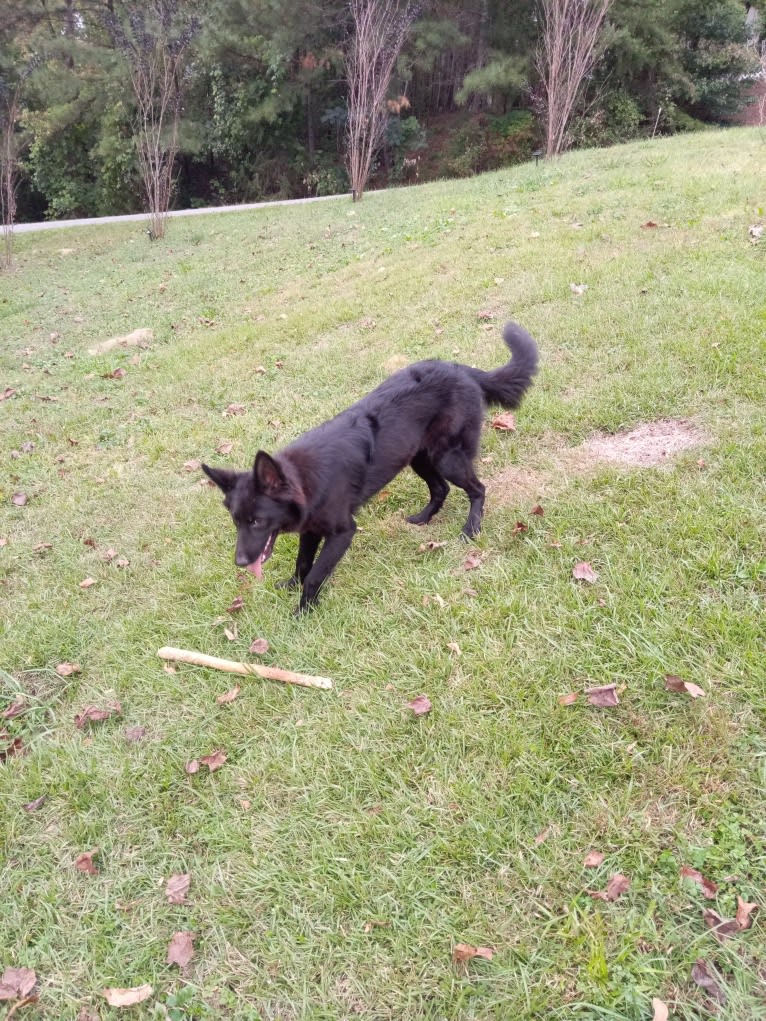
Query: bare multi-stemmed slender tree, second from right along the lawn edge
346 0 416 202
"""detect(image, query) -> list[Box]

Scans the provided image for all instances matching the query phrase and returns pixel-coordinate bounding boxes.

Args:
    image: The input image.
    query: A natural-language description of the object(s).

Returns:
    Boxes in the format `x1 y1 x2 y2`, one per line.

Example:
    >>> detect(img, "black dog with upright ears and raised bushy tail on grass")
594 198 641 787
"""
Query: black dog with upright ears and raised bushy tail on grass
202 323 537 610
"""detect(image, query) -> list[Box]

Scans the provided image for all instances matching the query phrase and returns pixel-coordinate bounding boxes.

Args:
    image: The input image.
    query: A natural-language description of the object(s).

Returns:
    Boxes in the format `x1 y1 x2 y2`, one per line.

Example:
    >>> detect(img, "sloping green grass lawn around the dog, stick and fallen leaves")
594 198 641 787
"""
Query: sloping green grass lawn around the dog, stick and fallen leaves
0 130 766 1021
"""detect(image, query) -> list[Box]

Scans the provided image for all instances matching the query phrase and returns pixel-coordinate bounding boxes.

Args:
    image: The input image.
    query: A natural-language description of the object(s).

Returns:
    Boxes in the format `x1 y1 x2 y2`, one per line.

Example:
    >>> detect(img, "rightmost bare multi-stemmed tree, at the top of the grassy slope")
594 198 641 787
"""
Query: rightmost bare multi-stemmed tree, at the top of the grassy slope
537 0 613 158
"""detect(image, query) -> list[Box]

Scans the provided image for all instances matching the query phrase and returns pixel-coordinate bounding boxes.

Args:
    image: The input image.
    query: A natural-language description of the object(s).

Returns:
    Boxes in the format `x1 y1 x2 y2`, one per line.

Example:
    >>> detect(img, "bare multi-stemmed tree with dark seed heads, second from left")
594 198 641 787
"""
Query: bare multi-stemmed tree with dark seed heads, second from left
107 0 199 238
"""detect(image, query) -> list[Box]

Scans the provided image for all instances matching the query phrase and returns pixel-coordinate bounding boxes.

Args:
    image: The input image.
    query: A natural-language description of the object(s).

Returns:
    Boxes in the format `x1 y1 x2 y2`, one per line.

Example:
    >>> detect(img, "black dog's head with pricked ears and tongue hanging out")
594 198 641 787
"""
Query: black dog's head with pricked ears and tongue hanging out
202 450 300 578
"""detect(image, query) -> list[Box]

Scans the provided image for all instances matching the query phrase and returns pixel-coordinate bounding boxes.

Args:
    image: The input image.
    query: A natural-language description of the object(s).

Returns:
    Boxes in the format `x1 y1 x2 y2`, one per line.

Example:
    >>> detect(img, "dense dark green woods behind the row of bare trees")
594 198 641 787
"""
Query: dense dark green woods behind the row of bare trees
0 0 763 227
